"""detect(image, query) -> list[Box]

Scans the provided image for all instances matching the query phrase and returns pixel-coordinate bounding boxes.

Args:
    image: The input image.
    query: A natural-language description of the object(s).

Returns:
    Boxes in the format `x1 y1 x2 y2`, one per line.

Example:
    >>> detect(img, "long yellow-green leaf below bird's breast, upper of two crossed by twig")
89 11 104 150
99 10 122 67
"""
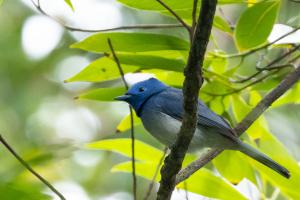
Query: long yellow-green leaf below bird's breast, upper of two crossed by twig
86 138 163 162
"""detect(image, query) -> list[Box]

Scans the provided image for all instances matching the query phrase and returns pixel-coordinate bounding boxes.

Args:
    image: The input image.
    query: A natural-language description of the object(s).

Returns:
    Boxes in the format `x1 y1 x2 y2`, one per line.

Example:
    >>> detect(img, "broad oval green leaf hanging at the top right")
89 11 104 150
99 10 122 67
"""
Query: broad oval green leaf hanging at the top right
234 1 280 50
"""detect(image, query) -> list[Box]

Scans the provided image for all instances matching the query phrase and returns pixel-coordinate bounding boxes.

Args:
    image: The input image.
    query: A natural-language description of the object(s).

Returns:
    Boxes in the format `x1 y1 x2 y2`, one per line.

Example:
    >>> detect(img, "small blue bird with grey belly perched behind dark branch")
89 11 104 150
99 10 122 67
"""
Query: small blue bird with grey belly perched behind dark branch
114 78 290 178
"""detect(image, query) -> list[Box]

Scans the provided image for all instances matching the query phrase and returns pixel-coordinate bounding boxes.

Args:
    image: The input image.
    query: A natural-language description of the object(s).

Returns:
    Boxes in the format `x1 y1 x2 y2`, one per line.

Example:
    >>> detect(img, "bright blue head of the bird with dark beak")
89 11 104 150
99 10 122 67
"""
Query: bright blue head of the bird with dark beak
115 78 168 113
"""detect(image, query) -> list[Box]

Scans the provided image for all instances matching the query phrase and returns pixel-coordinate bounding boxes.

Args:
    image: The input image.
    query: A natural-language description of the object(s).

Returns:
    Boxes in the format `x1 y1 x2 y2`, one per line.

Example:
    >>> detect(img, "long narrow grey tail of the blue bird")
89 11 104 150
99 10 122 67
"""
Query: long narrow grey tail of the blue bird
239 142 290 178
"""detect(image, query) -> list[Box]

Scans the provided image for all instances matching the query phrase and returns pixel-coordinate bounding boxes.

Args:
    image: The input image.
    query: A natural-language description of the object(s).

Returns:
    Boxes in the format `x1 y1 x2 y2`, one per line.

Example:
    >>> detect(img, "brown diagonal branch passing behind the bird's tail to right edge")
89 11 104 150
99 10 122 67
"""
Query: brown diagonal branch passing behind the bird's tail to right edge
176 66 300 184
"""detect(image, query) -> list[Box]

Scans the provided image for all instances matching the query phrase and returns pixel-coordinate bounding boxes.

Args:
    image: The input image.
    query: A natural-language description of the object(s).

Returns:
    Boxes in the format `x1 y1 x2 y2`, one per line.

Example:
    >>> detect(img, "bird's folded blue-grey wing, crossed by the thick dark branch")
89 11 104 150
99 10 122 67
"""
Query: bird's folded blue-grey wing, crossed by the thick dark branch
155 88 236 139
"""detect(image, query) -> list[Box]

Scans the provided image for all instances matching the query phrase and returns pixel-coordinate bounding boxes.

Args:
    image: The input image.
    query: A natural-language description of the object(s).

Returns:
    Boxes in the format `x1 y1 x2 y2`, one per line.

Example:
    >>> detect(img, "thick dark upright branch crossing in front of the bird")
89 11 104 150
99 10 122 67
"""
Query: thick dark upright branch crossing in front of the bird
157 0 217 200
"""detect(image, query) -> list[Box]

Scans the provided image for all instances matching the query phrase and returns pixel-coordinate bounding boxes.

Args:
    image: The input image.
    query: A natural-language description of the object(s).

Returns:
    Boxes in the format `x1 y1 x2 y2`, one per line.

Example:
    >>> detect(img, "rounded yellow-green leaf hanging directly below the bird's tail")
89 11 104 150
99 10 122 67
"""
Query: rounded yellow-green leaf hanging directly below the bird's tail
213 150 256 185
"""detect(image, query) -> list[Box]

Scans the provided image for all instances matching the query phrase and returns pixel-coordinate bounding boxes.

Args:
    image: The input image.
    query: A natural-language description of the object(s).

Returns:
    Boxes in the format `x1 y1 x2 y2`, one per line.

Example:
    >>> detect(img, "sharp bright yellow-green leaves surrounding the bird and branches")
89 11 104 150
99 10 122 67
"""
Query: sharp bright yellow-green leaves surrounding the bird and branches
67 0 300 199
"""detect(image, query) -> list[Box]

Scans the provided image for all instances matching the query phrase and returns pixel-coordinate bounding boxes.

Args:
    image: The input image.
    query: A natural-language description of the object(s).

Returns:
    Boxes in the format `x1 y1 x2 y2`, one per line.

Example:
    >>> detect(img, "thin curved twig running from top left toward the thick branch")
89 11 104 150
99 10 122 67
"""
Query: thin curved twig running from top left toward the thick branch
31 0 183 33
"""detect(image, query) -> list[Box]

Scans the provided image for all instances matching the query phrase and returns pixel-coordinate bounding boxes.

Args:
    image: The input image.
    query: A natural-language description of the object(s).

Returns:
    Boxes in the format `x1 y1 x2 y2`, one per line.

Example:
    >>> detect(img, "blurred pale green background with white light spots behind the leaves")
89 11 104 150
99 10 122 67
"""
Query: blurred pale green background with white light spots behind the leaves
0 0 300 200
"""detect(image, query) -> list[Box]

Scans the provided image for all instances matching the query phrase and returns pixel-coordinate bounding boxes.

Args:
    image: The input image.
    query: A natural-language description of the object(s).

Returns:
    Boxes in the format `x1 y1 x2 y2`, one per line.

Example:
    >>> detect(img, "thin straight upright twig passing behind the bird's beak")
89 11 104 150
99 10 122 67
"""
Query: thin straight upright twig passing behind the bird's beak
107 38 137 200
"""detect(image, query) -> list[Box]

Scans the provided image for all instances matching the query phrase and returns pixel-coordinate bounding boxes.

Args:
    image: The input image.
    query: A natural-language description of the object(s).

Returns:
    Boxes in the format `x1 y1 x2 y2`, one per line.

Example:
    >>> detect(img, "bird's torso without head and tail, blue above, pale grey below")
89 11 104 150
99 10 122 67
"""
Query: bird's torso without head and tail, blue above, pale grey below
139 87 236 150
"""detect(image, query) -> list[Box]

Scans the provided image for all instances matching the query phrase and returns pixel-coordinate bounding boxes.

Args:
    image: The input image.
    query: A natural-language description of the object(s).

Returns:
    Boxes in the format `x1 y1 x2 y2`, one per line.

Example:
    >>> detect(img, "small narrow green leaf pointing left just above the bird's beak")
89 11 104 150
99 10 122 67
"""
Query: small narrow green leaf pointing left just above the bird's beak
77 87 126 101
